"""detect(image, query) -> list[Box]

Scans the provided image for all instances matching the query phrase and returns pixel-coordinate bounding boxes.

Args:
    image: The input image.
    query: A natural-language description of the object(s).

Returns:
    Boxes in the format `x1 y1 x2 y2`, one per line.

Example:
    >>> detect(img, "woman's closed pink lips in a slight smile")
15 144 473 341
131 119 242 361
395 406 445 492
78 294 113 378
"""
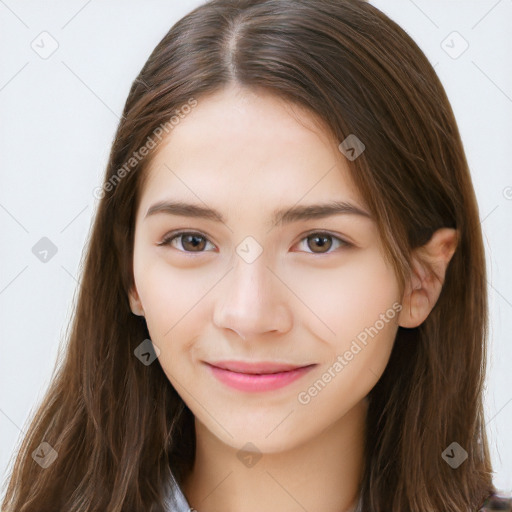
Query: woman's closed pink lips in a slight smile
206 361 316 391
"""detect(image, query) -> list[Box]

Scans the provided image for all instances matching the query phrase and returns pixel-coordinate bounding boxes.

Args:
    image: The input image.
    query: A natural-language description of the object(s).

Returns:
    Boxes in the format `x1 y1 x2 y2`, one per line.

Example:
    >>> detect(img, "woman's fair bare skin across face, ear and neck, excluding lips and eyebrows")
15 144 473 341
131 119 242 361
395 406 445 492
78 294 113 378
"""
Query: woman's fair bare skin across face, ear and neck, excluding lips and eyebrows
130 82 456 512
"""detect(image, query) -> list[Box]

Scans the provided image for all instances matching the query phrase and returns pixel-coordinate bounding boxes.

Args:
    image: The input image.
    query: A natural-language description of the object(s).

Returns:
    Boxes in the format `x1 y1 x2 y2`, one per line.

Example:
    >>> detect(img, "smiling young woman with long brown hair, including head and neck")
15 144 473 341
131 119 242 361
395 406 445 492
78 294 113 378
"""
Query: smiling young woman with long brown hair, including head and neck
3 0 510 512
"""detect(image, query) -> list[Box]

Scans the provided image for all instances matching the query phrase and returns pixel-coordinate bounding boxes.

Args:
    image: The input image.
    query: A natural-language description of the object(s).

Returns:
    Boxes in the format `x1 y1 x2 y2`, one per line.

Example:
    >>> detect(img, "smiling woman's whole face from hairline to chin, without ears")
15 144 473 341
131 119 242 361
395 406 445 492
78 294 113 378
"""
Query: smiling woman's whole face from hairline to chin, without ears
130 84 400 452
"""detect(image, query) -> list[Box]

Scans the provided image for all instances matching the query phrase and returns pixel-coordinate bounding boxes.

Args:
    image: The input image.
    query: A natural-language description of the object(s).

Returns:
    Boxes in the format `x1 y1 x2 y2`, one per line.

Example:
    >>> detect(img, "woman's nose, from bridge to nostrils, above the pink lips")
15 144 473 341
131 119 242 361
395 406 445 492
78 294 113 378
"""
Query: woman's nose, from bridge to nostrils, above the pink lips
214 257 293 341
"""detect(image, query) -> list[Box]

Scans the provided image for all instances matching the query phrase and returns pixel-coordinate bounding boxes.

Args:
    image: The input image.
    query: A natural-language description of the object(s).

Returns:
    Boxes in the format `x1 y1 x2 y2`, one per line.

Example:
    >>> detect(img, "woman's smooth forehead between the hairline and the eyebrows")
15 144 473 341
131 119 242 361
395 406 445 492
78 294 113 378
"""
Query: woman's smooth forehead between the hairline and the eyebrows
141 87 364 220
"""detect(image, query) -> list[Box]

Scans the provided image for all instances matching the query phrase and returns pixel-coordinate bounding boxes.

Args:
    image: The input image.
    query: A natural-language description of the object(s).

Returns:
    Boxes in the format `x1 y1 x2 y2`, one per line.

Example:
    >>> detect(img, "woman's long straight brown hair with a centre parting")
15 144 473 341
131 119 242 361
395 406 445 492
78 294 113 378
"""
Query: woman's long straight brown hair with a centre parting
3 0 496 512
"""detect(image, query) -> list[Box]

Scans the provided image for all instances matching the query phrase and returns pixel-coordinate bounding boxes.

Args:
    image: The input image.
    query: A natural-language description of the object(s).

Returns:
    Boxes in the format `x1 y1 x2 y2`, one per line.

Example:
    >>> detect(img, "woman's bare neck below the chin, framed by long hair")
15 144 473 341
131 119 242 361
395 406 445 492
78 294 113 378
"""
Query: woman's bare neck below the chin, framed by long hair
183 401 367 512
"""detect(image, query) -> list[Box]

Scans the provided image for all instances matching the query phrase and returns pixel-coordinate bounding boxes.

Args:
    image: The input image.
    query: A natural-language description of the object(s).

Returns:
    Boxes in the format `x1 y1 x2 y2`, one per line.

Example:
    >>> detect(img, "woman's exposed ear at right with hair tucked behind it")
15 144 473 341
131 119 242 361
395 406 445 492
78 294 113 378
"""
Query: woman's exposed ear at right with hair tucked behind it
398 228 458 328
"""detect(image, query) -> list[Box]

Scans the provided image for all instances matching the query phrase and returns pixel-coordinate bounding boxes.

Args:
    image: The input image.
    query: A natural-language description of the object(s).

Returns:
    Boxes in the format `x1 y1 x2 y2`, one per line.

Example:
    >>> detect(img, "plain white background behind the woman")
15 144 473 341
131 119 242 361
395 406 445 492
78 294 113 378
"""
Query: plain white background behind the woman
0 0 512 492
